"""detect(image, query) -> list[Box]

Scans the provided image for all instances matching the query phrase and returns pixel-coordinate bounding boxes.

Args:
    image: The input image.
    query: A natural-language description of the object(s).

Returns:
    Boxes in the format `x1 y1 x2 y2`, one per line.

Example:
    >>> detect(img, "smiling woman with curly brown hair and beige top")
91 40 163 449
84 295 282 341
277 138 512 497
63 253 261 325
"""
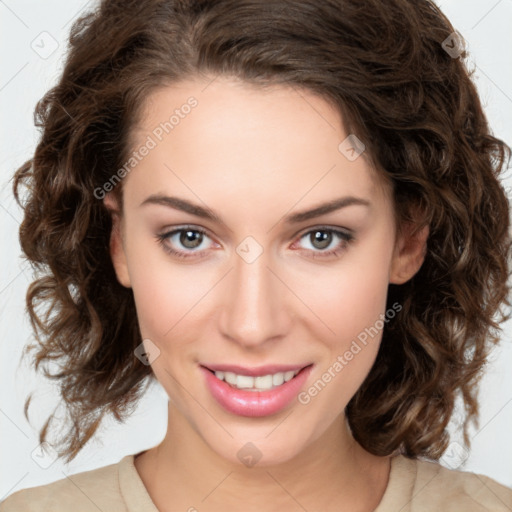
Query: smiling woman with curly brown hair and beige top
0 0 512 512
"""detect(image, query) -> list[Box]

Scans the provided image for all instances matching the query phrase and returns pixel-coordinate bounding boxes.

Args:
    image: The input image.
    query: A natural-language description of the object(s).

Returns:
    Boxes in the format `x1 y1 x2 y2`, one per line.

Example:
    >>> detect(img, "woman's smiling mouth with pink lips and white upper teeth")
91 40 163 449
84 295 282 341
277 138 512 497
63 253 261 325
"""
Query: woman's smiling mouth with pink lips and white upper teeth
199 363 313 417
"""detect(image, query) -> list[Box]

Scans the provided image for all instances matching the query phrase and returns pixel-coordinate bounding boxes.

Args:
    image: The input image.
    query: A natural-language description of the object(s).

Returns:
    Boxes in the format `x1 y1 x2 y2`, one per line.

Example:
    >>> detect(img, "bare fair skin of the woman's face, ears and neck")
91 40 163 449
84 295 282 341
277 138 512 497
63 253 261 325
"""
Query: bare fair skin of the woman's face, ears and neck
105 77 428 512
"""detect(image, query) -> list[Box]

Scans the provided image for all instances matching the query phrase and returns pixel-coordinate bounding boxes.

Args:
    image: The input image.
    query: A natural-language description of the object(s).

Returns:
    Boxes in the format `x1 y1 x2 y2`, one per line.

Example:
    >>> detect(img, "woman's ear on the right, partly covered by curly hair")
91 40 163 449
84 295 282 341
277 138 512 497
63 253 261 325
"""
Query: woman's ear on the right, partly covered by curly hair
389 222 429 284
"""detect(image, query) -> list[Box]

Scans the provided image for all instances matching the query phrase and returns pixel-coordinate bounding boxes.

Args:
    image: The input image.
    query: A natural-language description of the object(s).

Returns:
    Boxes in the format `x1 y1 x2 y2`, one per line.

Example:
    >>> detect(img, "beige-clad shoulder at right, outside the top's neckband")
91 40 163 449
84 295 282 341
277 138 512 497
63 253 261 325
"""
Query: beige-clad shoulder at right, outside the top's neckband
401 457 512 512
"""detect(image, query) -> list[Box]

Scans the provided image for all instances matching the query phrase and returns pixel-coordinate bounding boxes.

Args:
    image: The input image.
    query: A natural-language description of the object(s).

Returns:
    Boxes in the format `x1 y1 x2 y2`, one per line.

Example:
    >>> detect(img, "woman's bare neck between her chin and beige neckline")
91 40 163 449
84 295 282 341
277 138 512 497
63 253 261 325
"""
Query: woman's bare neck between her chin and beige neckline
135 402 390 512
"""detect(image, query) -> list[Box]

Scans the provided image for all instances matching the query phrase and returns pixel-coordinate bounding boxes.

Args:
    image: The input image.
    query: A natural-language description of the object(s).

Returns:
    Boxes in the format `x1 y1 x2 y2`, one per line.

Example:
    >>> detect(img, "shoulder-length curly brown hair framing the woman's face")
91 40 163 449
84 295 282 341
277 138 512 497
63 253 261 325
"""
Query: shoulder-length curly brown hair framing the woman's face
14 0 511 461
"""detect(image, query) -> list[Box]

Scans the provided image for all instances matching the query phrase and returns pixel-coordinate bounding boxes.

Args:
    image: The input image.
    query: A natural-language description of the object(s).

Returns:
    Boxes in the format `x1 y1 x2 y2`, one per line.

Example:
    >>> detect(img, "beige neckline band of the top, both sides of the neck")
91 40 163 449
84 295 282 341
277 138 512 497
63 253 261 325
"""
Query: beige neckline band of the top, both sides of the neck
118 452 417 512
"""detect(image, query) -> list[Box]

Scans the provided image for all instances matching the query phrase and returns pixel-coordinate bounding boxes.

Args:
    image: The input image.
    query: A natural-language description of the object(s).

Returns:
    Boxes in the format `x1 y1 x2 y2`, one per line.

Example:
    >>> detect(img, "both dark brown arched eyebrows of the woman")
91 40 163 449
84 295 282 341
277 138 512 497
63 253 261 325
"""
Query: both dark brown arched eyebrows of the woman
140 194 371 225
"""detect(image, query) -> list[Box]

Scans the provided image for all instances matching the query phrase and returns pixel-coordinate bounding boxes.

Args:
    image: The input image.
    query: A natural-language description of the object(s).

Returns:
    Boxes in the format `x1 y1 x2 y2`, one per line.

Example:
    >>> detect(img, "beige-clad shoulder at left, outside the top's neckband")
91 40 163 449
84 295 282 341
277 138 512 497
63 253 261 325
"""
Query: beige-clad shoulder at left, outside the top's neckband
0 456 126 512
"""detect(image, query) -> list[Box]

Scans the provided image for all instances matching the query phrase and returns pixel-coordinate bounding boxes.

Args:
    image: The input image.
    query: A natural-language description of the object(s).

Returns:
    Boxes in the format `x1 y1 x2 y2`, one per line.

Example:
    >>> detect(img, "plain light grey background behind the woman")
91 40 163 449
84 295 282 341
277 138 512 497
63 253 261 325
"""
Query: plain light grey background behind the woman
0 0 512 500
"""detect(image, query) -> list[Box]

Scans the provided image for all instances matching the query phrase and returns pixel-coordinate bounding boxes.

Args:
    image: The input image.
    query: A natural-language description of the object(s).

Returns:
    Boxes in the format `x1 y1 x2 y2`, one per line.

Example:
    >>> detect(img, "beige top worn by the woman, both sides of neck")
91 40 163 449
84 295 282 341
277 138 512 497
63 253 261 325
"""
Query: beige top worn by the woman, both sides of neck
0 455 512 512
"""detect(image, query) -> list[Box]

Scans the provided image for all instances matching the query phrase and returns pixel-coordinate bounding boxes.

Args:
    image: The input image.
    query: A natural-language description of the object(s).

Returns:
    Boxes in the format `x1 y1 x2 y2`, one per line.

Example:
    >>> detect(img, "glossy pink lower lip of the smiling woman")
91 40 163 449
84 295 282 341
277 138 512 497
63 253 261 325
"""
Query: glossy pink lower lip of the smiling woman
200 365 313 417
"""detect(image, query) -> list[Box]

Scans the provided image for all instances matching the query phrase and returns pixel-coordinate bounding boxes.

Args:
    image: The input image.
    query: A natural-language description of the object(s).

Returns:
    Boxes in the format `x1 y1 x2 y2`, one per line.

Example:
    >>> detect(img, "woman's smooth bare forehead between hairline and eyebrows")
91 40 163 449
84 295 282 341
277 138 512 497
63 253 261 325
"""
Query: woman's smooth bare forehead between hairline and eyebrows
128 77 392 208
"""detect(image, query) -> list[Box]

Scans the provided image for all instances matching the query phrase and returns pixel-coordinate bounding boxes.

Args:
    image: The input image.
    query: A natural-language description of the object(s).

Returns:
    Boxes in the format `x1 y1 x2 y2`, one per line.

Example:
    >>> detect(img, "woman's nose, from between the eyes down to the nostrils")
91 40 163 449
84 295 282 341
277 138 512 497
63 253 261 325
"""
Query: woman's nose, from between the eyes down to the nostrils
219 245 291 348
